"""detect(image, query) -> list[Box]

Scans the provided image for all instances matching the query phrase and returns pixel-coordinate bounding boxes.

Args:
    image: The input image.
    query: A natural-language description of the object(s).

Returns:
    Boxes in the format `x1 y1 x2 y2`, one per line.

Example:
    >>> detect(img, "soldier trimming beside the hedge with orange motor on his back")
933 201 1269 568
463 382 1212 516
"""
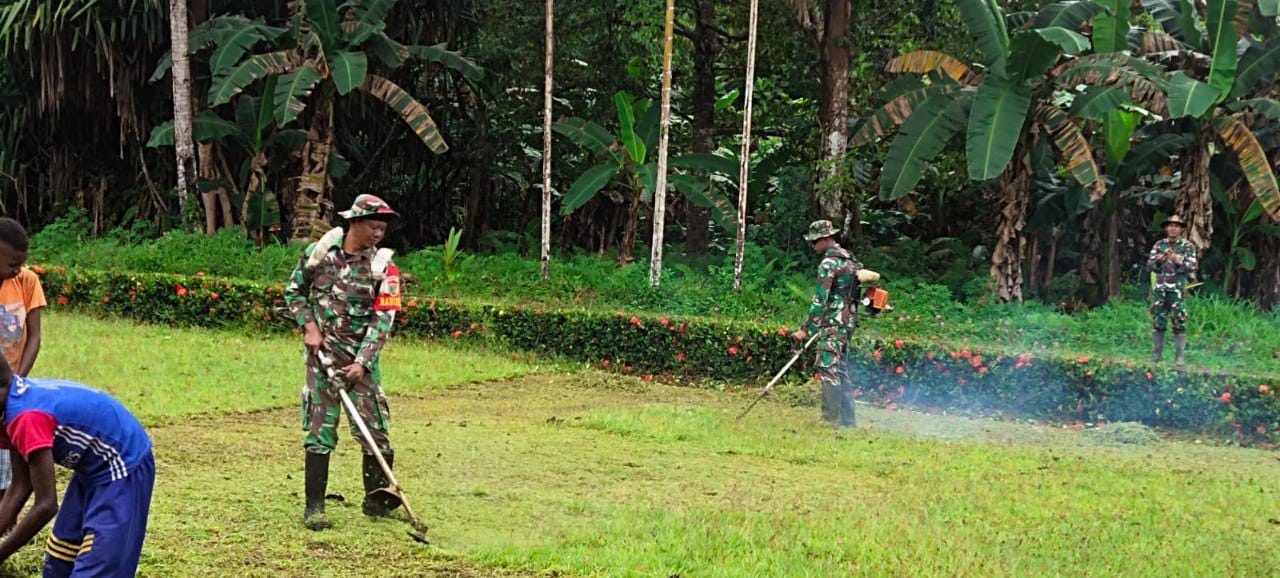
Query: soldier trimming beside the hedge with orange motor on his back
792 221 879 427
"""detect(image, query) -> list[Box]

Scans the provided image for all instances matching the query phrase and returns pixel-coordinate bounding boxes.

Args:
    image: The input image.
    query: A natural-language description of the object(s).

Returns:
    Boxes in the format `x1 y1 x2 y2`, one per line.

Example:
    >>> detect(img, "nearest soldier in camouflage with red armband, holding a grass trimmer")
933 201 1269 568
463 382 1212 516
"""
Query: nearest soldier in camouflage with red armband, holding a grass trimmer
284 194 401 529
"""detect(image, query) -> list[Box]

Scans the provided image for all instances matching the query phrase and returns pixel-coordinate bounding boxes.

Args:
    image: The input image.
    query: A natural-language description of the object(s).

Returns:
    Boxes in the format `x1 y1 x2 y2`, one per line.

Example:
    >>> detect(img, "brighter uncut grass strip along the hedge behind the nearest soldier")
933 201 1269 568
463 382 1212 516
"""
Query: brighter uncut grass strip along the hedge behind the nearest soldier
32 311 539 425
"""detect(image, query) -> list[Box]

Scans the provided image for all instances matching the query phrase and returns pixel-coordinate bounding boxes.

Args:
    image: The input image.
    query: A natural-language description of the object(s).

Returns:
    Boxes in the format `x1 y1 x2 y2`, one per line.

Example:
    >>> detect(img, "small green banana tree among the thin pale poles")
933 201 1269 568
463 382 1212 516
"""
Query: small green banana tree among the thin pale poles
554 91 737 263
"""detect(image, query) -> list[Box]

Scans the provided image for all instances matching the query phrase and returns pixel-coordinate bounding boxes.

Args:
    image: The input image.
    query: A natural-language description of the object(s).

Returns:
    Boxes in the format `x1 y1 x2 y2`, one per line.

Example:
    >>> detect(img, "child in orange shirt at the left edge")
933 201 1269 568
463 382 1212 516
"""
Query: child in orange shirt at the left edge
0 217 46 495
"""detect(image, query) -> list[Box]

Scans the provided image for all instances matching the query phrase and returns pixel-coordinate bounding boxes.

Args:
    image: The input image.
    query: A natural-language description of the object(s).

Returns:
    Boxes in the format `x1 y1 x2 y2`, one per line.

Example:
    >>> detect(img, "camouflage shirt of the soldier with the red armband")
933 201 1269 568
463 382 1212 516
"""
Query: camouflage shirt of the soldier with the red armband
284 240 396 368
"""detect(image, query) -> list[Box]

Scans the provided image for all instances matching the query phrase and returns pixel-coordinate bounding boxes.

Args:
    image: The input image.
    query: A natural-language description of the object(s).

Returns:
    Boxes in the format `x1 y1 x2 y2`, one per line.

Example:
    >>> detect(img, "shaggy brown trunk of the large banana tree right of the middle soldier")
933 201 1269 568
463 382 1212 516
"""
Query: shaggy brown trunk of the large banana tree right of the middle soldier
991 141 1036 302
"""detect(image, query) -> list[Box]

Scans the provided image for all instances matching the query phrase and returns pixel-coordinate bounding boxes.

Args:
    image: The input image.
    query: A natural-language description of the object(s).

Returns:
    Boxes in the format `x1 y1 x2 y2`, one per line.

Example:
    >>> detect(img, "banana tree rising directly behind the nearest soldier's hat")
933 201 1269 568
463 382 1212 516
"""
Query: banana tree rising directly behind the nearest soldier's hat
209 0 481 239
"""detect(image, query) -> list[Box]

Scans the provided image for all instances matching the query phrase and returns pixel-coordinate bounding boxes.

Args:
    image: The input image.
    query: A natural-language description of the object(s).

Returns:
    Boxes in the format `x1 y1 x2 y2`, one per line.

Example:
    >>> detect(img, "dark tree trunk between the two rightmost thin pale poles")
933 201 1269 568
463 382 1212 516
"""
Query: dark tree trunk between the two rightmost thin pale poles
685 0 722 254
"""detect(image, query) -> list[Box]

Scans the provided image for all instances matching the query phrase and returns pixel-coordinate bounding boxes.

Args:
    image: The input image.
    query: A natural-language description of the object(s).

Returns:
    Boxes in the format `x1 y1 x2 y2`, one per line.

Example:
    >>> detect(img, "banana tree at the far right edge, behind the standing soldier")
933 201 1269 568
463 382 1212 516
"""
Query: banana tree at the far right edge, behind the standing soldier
1139 0 1280 251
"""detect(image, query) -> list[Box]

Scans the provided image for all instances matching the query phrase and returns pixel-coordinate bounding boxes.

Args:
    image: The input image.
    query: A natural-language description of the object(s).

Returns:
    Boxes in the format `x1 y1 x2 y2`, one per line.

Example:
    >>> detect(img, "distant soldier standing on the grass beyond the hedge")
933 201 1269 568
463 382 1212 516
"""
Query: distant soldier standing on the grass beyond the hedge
1147 215 1197 371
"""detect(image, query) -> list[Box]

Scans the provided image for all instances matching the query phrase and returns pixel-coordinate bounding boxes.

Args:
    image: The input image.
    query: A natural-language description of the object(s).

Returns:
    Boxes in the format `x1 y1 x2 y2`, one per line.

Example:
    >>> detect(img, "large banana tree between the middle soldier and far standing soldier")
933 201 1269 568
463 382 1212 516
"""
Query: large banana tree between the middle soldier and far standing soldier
851 0 1165 301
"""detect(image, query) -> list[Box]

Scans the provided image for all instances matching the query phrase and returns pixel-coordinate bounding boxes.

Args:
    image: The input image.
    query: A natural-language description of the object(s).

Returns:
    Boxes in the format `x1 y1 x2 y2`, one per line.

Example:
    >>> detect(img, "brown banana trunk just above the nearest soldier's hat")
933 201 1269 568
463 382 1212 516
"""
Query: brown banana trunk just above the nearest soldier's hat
291 90 333 242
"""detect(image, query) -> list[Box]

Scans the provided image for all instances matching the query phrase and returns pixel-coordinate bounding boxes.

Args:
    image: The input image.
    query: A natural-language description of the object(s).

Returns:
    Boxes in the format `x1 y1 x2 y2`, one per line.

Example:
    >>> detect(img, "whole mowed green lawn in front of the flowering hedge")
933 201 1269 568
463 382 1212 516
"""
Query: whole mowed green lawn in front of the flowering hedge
4 313 1280 577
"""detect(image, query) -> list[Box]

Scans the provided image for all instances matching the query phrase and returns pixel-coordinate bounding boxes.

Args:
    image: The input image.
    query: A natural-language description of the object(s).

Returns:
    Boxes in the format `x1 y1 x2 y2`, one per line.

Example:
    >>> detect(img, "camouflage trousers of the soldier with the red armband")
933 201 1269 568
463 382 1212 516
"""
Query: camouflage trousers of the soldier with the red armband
302 353 392 455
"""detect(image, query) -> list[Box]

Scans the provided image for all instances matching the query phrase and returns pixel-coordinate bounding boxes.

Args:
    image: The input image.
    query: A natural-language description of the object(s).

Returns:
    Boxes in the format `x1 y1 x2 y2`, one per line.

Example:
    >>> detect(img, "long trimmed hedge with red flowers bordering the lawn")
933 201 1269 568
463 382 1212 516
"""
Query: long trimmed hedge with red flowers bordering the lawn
32 267 1280 440
